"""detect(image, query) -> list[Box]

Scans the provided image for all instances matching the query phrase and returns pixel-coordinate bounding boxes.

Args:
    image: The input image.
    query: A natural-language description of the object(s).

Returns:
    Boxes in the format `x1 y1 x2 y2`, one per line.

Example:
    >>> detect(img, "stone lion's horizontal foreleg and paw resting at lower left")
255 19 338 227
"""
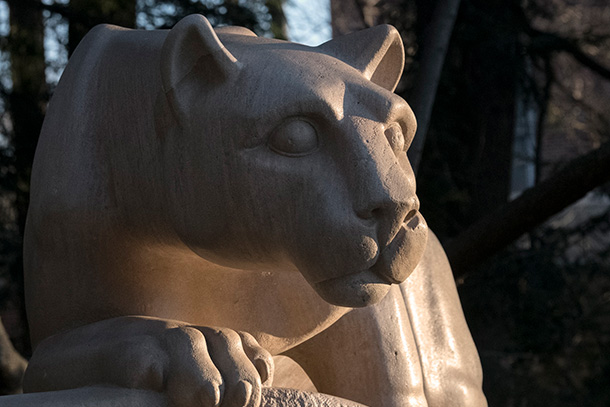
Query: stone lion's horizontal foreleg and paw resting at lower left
24 317 274 407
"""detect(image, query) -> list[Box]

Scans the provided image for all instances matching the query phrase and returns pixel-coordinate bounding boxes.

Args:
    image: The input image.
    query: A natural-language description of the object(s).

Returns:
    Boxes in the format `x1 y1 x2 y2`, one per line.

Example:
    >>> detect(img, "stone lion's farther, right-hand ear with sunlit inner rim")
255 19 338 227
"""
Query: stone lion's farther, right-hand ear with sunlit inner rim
318 24 405 91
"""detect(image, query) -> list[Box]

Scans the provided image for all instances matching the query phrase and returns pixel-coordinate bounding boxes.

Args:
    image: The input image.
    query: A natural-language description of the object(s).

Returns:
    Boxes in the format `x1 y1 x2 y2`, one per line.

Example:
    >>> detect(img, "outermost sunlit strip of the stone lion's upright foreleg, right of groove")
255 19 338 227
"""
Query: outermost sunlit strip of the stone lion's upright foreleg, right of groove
400 233 487 407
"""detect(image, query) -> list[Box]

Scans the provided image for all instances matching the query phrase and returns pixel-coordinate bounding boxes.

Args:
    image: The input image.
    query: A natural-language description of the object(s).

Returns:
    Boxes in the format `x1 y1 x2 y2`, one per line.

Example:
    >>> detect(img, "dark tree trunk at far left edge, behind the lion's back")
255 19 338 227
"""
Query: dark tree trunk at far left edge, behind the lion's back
0 0 48 364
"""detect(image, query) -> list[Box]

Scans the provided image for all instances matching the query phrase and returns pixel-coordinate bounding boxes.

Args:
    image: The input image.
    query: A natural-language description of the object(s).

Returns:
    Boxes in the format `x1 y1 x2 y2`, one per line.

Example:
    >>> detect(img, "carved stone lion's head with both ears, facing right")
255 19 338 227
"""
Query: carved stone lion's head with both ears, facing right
156 16 427 307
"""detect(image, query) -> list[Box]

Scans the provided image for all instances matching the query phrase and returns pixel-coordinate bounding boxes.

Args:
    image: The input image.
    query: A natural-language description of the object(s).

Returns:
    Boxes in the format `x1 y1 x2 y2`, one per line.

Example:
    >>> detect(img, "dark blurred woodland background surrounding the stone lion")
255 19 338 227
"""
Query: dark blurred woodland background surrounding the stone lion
0 0 610 407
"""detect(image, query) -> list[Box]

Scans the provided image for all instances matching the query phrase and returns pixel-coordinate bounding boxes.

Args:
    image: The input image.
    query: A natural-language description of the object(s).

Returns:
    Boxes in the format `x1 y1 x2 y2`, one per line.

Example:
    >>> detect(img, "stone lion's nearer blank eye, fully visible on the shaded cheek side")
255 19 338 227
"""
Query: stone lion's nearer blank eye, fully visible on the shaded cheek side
268 119 318 157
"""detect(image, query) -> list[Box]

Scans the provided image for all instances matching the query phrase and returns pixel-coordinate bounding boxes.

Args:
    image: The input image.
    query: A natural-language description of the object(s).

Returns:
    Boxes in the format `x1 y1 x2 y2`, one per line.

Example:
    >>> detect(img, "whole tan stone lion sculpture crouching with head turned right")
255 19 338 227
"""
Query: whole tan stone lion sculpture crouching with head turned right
7 15 486 407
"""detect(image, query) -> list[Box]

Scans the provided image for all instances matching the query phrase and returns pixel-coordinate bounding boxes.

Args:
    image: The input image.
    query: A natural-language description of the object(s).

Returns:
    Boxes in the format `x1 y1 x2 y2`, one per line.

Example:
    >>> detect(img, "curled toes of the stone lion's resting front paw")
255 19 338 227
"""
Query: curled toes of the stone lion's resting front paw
160 326 273 407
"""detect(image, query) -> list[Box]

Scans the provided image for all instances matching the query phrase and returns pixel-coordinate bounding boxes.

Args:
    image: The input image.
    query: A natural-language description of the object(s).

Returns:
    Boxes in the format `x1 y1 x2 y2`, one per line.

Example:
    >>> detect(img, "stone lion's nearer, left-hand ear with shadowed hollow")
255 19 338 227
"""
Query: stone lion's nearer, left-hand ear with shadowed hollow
161 14 241 115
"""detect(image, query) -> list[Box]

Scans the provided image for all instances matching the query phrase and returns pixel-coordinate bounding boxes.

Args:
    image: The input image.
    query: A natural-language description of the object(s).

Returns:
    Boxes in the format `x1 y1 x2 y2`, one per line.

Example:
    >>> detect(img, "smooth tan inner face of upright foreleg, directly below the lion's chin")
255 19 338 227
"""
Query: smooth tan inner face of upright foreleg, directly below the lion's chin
287 286 427 407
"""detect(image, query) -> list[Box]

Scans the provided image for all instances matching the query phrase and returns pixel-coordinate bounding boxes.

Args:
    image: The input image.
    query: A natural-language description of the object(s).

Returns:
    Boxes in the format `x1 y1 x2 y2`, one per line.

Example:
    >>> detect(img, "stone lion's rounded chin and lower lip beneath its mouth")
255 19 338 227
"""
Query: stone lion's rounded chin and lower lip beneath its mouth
313 270 391 308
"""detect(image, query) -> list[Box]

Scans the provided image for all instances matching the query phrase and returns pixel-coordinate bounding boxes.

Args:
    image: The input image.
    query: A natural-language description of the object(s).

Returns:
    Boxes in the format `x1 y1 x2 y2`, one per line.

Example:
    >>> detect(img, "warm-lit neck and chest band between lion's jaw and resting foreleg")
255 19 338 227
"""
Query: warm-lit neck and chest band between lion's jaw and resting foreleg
28 218 347 353
